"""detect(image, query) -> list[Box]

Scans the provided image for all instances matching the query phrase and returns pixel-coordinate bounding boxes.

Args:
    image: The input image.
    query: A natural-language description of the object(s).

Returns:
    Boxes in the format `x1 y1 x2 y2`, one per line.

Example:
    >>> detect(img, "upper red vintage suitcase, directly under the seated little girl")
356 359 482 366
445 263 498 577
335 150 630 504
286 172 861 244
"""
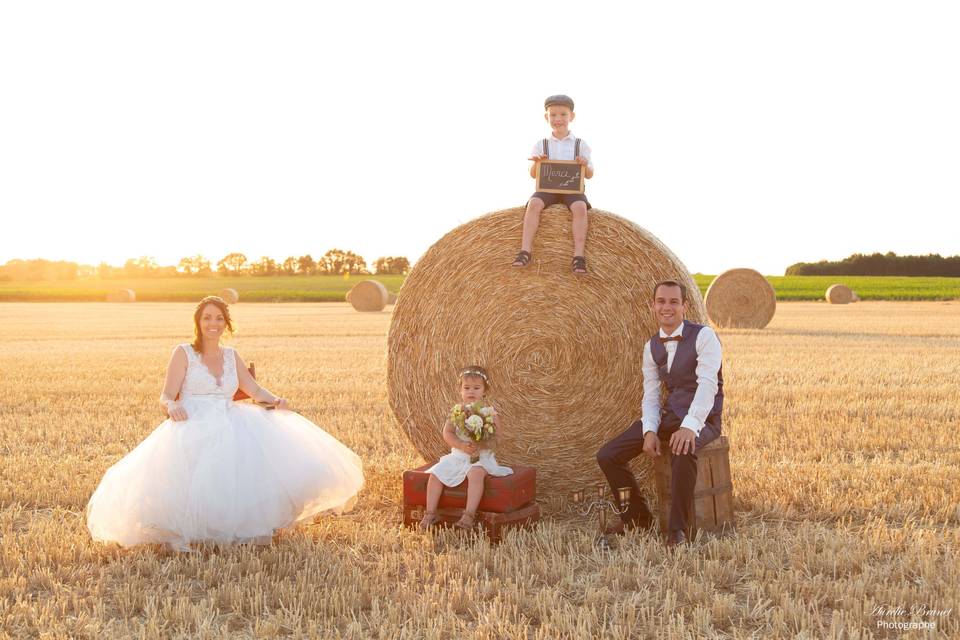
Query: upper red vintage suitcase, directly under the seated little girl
403 464 537 517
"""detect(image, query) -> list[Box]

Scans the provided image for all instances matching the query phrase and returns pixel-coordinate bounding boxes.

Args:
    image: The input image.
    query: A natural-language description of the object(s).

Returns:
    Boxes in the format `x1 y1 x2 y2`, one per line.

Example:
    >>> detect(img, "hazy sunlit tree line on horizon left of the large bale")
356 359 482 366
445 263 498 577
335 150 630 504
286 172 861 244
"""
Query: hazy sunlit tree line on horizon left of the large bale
0 249 410 280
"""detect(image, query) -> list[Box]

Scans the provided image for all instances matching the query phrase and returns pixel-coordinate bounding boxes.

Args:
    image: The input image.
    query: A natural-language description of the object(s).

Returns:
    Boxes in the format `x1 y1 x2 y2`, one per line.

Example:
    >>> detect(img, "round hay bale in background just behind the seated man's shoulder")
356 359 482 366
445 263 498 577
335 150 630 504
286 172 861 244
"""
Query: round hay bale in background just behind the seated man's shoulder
704 269 777 329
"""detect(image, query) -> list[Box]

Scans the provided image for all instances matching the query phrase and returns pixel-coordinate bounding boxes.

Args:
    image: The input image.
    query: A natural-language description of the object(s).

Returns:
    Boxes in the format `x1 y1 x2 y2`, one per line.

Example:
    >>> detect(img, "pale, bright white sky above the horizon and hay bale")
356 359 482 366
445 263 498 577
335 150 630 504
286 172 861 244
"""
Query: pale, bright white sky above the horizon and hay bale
0 0 960 275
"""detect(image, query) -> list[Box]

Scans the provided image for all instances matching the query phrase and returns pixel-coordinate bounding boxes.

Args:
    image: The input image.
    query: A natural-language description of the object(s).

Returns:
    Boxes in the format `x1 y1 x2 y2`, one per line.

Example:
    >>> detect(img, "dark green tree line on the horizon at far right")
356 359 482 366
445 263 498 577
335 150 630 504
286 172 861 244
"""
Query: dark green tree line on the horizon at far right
785 251 960 278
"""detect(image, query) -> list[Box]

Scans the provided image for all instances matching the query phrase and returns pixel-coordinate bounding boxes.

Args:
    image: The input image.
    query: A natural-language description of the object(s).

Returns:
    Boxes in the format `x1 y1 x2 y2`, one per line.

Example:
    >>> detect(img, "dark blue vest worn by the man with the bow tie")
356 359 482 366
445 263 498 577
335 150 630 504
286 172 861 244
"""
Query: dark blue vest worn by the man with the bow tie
650 320 723 435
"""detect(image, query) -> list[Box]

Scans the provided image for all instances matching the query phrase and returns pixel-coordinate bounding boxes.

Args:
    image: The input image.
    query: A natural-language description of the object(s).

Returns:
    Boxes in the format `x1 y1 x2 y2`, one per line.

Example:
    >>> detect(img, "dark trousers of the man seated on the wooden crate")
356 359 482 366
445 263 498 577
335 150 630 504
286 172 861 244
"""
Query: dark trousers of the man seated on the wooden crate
597 411 720 533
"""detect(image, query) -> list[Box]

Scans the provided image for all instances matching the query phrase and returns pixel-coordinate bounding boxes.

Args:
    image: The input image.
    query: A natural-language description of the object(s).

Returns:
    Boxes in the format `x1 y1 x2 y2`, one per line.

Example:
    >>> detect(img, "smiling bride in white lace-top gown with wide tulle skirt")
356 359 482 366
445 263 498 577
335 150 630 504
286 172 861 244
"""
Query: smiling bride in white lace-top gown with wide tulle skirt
87 296 363 551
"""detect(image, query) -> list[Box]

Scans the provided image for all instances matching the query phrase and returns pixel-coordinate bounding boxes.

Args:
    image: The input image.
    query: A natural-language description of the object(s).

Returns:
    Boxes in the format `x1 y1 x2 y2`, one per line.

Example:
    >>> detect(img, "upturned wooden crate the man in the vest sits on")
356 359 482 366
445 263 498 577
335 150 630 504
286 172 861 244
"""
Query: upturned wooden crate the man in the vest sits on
653 436 734 540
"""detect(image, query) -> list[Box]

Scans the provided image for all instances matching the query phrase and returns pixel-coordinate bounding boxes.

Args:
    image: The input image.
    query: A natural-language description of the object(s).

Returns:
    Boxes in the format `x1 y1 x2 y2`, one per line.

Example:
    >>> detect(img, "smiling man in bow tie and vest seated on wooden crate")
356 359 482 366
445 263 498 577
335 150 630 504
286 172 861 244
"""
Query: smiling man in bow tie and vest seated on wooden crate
597 280 723 546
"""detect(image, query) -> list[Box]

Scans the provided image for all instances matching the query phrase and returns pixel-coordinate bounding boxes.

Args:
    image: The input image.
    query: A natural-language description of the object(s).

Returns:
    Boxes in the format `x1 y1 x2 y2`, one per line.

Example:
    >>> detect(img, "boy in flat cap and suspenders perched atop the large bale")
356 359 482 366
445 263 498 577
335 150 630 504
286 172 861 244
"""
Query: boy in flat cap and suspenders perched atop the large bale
513 95 593 274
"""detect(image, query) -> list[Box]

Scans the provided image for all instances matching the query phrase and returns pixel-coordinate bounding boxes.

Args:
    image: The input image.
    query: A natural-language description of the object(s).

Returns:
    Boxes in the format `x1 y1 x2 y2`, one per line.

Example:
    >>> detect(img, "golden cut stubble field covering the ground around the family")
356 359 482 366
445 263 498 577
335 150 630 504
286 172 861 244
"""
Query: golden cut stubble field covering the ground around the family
0 302 960 638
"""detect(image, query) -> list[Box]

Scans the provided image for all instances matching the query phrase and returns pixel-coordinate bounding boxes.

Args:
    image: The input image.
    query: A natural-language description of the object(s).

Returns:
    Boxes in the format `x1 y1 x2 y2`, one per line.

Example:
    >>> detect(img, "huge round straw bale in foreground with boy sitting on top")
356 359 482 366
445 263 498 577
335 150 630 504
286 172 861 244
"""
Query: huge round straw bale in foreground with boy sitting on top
387 207 706 496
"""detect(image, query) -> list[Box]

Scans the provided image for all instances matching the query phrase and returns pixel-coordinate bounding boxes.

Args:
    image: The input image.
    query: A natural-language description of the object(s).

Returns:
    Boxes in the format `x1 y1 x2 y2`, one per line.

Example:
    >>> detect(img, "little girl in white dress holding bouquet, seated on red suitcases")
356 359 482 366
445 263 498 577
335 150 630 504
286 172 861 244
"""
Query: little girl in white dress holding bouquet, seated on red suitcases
420 365 513 529
